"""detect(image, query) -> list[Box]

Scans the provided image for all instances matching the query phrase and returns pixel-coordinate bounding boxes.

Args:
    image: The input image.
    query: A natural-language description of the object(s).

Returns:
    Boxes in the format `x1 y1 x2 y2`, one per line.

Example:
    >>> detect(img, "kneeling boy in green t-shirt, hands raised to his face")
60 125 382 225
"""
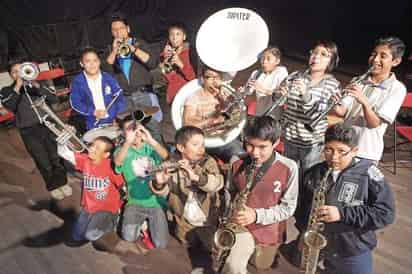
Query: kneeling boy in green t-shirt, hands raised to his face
114 114 169 248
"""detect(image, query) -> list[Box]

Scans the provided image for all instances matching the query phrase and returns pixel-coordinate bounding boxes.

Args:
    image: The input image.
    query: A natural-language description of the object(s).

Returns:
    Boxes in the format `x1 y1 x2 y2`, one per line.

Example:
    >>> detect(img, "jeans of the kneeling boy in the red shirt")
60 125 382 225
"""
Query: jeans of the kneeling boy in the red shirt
72 209 119 241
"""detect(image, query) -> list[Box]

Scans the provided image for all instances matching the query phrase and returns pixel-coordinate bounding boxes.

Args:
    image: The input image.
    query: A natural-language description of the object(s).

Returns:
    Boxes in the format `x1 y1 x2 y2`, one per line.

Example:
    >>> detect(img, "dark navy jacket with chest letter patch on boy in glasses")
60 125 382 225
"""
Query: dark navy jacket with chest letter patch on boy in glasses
295 159 395 257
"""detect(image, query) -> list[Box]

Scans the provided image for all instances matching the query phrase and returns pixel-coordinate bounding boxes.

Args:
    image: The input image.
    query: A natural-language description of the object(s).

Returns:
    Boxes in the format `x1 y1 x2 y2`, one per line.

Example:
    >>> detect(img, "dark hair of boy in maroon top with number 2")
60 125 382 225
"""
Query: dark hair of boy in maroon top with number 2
244 116 281 144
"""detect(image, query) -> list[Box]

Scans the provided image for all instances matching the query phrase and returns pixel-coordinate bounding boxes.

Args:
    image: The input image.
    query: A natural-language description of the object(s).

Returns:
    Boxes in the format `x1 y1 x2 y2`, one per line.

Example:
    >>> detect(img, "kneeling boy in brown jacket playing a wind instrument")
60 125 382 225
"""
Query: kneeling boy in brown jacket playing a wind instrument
151 126 224 251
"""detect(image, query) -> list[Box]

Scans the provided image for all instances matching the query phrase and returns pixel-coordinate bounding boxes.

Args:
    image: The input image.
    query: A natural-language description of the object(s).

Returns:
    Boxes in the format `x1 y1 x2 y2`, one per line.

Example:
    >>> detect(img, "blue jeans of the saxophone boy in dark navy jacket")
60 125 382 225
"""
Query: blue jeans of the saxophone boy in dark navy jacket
321 251 373 274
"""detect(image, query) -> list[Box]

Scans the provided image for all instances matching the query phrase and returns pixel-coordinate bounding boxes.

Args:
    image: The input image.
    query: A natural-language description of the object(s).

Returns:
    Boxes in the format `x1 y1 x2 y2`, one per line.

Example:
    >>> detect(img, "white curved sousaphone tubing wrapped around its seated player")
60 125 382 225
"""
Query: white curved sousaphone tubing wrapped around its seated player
172 79 246 148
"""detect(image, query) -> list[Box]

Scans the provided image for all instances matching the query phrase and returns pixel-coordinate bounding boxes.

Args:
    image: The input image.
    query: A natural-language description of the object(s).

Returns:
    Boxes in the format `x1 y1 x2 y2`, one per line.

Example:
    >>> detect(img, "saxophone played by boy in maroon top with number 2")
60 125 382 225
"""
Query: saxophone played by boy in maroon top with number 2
212 160 256 273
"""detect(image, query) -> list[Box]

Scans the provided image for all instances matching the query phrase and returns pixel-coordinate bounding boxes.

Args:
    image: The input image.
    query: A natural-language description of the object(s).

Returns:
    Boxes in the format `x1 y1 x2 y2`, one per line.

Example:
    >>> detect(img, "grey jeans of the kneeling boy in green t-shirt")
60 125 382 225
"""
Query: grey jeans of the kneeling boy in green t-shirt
122 205 169 248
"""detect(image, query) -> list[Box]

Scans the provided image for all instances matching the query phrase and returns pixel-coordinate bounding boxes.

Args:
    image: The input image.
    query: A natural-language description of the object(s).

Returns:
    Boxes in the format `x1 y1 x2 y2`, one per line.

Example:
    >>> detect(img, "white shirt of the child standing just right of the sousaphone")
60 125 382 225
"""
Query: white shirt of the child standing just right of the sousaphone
248 66 288 97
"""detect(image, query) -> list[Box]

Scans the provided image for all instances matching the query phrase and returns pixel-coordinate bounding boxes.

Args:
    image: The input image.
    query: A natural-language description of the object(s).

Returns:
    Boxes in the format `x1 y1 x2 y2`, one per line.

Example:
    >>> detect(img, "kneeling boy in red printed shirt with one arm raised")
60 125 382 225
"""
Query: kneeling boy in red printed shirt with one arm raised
58 136 124 242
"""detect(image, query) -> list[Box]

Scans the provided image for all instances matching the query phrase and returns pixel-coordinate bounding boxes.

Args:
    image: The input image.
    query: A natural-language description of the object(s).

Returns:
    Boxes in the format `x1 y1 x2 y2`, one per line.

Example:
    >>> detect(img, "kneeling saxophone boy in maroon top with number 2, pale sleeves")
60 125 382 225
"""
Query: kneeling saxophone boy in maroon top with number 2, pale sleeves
219 116 298 274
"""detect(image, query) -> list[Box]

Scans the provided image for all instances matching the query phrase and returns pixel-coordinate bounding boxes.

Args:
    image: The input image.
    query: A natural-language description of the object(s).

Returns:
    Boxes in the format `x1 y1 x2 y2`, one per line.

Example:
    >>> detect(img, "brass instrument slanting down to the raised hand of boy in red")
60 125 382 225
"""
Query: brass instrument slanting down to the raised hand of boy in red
32 96 88 152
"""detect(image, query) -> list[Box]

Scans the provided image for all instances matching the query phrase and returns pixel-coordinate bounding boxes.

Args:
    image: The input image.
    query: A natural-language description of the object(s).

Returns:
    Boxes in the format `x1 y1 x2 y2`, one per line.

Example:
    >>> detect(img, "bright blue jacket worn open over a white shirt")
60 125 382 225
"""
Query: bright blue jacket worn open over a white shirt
70 72 126 129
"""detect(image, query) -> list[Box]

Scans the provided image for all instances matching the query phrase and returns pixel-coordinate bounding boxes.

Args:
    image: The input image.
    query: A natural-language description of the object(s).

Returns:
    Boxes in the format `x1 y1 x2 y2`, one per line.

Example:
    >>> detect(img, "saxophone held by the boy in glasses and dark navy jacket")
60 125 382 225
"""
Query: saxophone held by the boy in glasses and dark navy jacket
301 168 332 274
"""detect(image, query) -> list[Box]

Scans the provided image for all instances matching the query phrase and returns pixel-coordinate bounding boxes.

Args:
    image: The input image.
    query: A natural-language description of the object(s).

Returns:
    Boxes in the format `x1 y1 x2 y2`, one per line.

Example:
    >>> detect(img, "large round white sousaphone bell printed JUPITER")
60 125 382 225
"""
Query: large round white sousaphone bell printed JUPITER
196 8 269 72
